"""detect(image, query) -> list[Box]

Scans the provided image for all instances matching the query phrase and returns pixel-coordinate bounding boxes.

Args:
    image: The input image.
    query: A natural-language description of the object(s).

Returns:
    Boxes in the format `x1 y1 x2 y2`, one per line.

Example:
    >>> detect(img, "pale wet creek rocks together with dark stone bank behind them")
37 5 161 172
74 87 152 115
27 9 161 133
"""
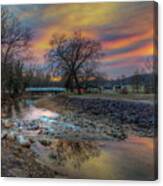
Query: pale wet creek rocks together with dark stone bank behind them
2 97 155 143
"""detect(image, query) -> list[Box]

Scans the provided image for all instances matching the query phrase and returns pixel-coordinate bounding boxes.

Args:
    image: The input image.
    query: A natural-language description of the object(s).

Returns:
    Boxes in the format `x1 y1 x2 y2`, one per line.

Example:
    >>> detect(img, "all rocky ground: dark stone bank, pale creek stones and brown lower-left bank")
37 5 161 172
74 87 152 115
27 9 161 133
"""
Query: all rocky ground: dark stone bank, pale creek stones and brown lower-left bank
1 96 157 177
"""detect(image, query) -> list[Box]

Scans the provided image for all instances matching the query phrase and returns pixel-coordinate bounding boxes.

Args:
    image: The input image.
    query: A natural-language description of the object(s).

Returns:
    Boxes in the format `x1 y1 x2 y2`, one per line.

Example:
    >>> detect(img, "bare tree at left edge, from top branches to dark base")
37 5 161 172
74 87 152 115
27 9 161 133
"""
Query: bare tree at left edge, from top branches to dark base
1 6 32 97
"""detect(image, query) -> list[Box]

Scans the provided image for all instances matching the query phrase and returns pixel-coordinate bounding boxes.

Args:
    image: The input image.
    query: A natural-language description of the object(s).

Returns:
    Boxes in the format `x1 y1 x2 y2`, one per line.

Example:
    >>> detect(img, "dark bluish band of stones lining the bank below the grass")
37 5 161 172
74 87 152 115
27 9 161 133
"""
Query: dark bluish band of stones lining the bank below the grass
67 97 157 126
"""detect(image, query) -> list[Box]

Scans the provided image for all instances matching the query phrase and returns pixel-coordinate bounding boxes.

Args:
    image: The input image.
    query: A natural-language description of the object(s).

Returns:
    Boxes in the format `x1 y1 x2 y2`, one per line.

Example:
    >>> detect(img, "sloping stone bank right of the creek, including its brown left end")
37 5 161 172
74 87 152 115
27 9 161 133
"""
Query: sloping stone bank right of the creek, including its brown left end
38 96 157 139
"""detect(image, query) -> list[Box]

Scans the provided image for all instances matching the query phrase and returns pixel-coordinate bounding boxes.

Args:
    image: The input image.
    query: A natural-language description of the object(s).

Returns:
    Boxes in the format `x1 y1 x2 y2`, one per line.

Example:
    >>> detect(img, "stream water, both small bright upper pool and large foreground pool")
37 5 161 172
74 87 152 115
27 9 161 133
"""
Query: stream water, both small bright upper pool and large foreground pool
1 100 156 180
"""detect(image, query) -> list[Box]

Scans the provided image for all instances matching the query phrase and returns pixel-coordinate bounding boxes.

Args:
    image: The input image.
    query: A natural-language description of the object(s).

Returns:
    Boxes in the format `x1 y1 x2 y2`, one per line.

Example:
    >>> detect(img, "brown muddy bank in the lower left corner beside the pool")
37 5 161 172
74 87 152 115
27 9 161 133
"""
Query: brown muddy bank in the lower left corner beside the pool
1 139 66 178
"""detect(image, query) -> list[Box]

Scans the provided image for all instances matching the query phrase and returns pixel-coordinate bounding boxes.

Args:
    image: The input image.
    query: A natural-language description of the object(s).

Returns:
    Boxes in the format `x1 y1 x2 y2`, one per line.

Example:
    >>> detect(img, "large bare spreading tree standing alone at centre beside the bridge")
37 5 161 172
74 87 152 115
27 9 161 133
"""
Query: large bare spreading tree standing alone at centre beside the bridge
47 32 101 94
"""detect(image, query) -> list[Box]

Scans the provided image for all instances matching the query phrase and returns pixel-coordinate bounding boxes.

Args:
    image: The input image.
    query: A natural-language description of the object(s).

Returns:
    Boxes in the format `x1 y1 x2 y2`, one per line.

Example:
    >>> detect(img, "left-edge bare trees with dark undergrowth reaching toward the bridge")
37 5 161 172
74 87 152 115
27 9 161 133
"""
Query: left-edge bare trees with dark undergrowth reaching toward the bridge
1 6 53 100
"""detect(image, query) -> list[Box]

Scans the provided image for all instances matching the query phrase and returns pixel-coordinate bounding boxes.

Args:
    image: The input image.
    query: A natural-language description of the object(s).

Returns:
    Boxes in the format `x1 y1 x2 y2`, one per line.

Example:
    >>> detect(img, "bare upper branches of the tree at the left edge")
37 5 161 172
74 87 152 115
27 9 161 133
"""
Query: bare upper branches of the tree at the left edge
1 7 32 63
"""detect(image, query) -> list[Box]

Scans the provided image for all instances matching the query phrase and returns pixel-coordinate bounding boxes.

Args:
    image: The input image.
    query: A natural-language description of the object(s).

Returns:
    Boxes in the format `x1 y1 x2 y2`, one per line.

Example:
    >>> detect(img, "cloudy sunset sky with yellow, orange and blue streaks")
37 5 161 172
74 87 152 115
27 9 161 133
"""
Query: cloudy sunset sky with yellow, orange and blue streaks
6 1 156 79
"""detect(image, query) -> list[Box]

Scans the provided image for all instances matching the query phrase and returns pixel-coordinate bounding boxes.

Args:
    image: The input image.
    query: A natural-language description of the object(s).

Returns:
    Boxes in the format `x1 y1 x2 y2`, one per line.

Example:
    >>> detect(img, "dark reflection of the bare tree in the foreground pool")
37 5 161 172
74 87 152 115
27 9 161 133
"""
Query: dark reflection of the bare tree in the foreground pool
49 140 100 168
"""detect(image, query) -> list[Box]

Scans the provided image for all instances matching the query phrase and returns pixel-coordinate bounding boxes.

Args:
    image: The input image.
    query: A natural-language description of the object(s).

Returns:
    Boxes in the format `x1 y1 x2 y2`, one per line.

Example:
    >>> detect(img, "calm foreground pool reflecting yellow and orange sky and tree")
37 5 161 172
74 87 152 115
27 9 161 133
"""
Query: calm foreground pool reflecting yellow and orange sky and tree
49 136 155 180
